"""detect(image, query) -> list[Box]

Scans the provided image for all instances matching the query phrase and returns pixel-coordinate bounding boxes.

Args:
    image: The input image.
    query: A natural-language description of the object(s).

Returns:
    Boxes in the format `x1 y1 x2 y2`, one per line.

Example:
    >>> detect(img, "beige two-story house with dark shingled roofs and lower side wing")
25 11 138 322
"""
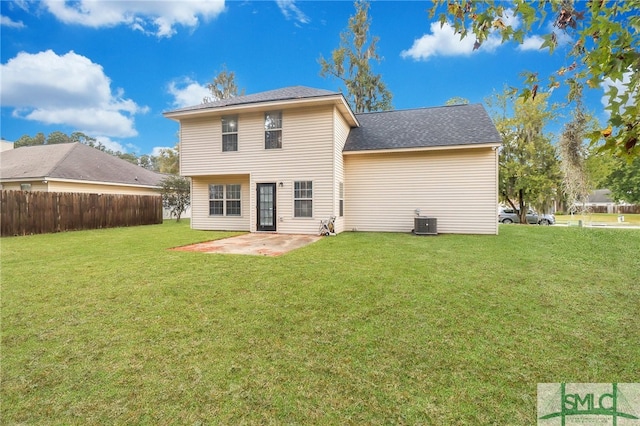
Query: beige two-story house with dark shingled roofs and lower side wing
164 86 501 234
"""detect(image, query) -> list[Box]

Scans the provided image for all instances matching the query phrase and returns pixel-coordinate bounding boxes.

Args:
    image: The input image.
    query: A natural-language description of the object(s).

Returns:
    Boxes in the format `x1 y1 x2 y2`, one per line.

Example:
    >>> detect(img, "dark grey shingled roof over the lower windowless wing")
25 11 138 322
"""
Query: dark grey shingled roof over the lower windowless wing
344 104 502 152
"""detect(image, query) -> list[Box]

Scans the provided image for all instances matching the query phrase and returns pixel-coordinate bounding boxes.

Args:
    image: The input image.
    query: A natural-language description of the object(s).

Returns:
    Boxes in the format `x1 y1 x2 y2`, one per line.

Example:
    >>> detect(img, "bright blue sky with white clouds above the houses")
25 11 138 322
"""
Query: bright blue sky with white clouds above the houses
0 0 606 155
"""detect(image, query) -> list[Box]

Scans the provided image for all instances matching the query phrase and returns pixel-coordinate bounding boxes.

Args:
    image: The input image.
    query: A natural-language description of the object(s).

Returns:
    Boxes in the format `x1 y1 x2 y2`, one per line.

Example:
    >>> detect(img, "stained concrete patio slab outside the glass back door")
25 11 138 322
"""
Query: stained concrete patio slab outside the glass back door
172 233 322 256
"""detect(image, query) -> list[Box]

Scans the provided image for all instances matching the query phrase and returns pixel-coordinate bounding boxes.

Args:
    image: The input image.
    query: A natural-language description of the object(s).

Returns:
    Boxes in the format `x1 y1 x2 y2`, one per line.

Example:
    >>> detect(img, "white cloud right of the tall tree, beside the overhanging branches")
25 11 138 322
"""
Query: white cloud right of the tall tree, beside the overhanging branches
400 22 501 61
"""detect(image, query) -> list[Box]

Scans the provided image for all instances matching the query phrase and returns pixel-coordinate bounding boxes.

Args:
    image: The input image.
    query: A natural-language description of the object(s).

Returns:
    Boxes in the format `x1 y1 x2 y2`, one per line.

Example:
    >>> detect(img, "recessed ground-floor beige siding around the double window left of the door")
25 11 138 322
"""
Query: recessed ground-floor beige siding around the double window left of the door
191 175 251 231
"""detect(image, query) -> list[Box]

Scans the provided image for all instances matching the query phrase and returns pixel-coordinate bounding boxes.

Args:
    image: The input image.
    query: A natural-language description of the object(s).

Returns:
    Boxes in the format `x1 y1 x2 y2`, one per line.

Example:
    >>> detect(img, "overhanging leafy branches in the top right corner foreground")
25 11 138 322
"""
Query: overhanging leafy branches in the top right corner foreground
431 0 640 157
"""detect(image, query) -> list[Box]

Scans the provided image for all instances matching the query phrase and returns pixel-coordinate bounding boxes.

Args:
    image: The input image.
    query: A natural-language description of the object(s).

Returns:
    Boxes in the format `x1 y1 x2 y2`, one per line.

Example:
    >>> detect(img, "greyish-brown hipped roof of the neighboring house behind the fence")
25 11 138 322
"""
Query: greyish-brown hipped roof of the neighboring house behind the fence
0 142 164 187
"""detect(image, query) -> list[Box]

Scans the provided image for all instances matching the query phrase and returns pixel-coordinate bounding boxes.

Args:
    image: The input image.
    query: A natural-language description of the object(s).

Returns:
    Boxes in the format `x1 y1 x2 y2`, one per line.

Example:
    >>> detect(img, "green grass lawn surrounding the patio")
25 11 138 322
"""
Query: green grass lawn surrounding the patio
0 222 640 425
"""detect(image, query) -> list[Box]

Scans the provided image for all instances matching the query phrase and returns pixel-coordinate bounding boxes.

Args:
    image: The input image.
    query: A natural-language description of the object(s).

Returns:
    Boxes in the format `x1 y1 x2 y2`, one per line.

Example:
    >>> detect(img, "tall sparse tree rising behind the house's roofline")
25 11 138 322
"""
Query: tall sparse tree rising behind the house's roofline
318 0 392 113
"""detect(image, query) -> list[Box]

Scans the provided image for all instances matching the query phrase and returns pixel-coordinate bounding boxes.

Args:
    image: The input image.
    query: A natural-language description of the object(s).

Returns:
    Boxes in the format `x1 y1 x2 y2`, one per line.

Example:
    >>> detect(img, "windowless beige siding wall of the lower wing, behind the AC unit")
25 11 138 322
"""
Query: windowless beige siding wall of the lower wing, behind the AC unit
345 148 498 234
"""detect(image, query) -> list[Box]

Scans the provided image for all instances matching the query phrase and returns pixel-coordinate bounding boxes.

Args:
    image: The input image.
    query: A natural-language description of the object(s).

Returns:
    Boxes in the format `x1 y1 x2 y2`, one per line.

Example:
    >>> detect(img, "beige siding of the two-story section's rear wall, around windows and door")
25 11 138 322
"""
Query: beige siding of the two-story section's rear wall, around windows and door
180 106 335 234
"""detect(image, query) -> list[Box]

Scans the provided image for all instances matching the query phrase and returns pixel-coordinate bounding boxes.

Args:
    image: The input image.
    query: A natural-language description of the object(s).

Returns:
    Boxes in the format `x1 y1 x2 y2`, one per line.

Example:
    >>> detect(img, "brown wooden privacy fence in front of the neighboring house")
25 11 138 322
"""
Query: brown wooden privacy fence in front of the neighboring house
0 191 162 237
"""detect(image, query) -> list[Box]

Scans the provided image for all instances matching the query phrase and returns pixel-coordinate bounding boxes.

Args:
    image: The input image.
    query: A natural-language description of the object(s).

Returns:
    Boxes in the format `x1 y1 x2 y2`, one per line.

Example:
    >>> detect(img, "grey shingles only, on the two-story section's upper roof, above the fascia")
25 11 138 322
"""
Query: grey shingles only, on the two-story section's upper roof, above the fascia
169 86 340 113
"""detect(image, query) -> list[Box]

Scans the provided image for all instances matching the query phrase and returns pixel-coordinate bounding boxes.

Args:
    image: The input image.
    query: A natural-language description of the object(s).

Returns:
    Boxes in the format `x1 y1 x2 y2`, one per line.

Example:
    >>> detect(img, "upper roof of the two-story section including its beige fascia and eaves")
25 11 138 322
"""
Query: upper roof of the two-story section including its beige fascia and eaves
164 86 358 127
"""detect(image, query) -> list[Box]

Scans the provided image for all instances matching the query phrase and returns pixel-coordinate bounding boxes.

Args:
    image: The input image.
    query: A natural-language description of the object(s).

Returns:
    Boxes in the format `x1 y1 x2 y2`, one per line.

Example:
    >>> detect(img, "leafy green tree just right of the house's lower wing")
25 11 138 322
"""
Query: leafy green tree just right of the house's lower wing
488 91 560 223
